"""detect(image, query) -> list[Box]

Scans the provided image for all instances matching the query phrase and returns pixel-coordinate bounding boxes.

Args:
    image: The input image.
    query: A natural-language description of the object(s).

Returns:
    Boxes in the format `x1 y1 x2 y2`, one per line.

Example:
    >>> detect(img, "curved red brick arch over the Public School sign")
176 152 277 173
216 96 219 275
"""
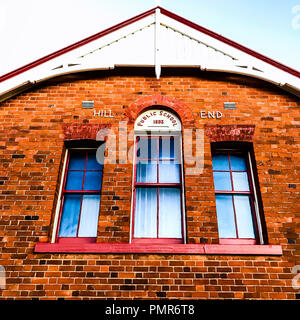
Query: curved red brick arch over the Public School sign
125 94 195 127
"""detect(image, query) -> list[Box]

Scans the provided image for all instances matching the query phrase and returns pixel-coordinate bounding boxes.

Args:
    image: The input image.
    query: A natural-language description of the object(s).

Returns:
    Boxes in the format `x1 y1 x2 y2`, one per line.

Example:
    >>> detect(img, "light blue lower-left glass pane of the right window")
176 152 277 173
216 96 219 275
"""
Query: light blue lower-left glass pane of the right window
216 194 236 238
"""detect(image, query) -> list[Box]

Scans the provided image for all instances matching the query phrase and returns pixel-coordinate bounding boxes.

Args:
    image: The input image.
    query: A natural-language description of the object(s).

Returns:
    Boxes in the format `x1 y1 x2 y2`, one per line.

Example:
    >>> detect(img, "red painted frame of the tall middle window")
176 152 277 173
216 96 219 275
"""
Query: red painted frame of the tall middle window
131 134 184 245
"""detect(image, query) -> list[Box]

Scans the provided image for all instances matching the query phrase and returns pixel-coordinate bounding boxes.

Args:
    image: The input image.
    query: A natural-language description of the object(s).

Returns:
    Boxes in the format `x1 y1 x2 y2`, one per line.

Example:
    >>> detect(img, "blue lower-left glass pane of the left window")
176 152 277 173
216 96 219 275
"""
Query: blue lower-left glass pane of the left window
58 194 81 237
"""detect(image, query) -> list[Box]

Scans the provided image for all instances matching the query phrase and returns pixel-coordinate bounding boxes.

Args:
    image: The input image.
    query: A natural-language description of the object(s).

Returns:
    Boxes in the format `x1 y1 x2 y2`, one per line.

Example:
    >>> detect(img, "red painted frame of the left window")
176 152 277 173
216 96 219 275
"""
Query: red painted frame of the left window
55 148 103 244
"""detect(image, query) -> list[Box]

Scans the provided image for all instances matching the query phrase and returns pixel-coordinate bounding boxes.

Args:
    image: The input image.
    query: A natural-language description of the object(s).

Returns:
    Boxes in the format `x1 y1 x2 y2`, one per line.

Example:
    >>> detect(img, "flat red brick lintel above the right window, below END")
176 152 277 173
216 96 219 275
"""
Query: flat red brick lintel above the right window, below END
205 124 255 142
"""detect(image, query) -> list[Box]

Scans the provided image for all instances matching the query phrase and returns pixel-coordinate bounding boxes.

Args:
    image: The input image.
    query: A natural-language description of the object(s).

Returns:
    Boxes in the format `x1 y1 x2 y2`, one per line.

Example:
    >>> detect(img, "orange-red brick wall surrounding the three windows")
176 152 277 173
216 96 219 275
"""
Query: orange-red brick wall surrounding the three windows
0 69 300 299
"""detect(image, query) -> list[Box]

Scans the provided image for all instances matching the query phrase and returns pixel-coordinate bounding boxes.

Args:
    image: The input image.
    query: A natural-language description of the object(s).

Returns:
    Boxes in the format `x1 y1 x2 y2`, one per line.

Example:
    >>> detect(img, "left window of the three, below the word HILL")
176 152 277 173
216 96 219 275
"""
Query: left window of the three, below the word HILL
57 149 103 242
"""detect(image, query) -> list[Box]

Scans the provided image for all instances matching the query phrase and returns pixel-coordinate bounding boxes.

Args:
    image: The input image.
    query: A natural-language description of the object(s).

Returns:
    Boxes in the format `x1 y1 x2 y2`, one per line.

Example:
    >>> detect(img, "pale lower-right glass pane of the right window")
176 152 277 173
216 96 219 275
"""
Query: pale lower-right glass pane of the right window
234 195 255 239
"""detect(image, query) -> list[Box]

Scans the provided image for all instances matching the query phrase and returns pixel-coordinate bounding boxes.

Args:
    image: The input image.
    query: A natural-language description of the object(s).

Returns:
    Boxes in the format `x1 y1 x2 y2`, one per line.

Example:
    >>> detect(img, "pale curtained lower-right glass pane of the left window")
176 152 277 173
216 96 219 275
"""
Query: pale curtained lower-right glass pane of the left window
78 195 100 237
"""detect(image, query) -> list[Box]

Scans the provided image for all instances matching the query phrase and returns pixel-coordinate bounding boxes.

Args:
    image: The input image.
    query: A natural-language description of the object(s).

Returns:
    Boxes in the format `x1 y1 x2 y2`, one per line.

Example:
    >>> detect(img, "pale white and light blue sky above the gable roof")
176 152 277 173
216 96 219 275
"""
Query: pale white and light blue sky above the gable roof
0 0 300 75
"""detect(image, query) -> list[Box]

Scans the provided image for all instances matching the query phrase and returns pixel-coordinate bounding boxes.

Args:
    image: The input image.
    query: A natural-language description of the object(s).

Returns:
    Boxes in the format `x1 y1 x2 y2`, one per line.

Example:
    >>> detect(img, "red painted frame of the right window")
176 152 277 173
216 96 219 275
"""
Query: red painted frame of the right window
212 148 260 245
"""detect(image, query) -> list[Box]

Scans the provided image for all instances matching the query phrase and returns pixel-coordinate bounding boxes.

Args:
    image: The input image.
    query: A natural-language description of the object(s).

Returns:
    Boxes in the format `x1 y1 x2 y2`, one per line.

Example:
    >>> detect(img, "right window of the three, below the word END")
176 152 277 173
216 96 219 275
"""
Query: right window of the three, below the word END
212 149 262 244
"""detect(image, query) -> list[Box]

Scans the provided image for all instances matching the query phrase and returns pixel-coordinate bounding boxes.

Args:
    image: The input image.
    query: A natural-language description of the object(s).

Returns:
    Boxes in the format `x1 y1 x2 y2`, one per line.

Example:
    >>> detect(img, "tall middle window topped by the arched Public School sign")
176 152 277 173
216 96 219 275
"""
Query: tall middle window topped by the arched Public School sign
132 110 184 243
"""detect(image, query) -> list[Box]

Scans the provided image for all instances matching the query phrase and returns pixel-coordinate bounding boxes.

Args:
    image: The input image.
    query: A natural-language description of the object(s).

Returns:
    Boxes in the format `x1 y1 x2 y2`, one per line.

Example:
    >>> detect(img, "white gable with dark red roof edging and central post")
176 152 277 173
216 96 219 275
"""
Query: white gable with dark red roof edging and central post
0 6 300 101
